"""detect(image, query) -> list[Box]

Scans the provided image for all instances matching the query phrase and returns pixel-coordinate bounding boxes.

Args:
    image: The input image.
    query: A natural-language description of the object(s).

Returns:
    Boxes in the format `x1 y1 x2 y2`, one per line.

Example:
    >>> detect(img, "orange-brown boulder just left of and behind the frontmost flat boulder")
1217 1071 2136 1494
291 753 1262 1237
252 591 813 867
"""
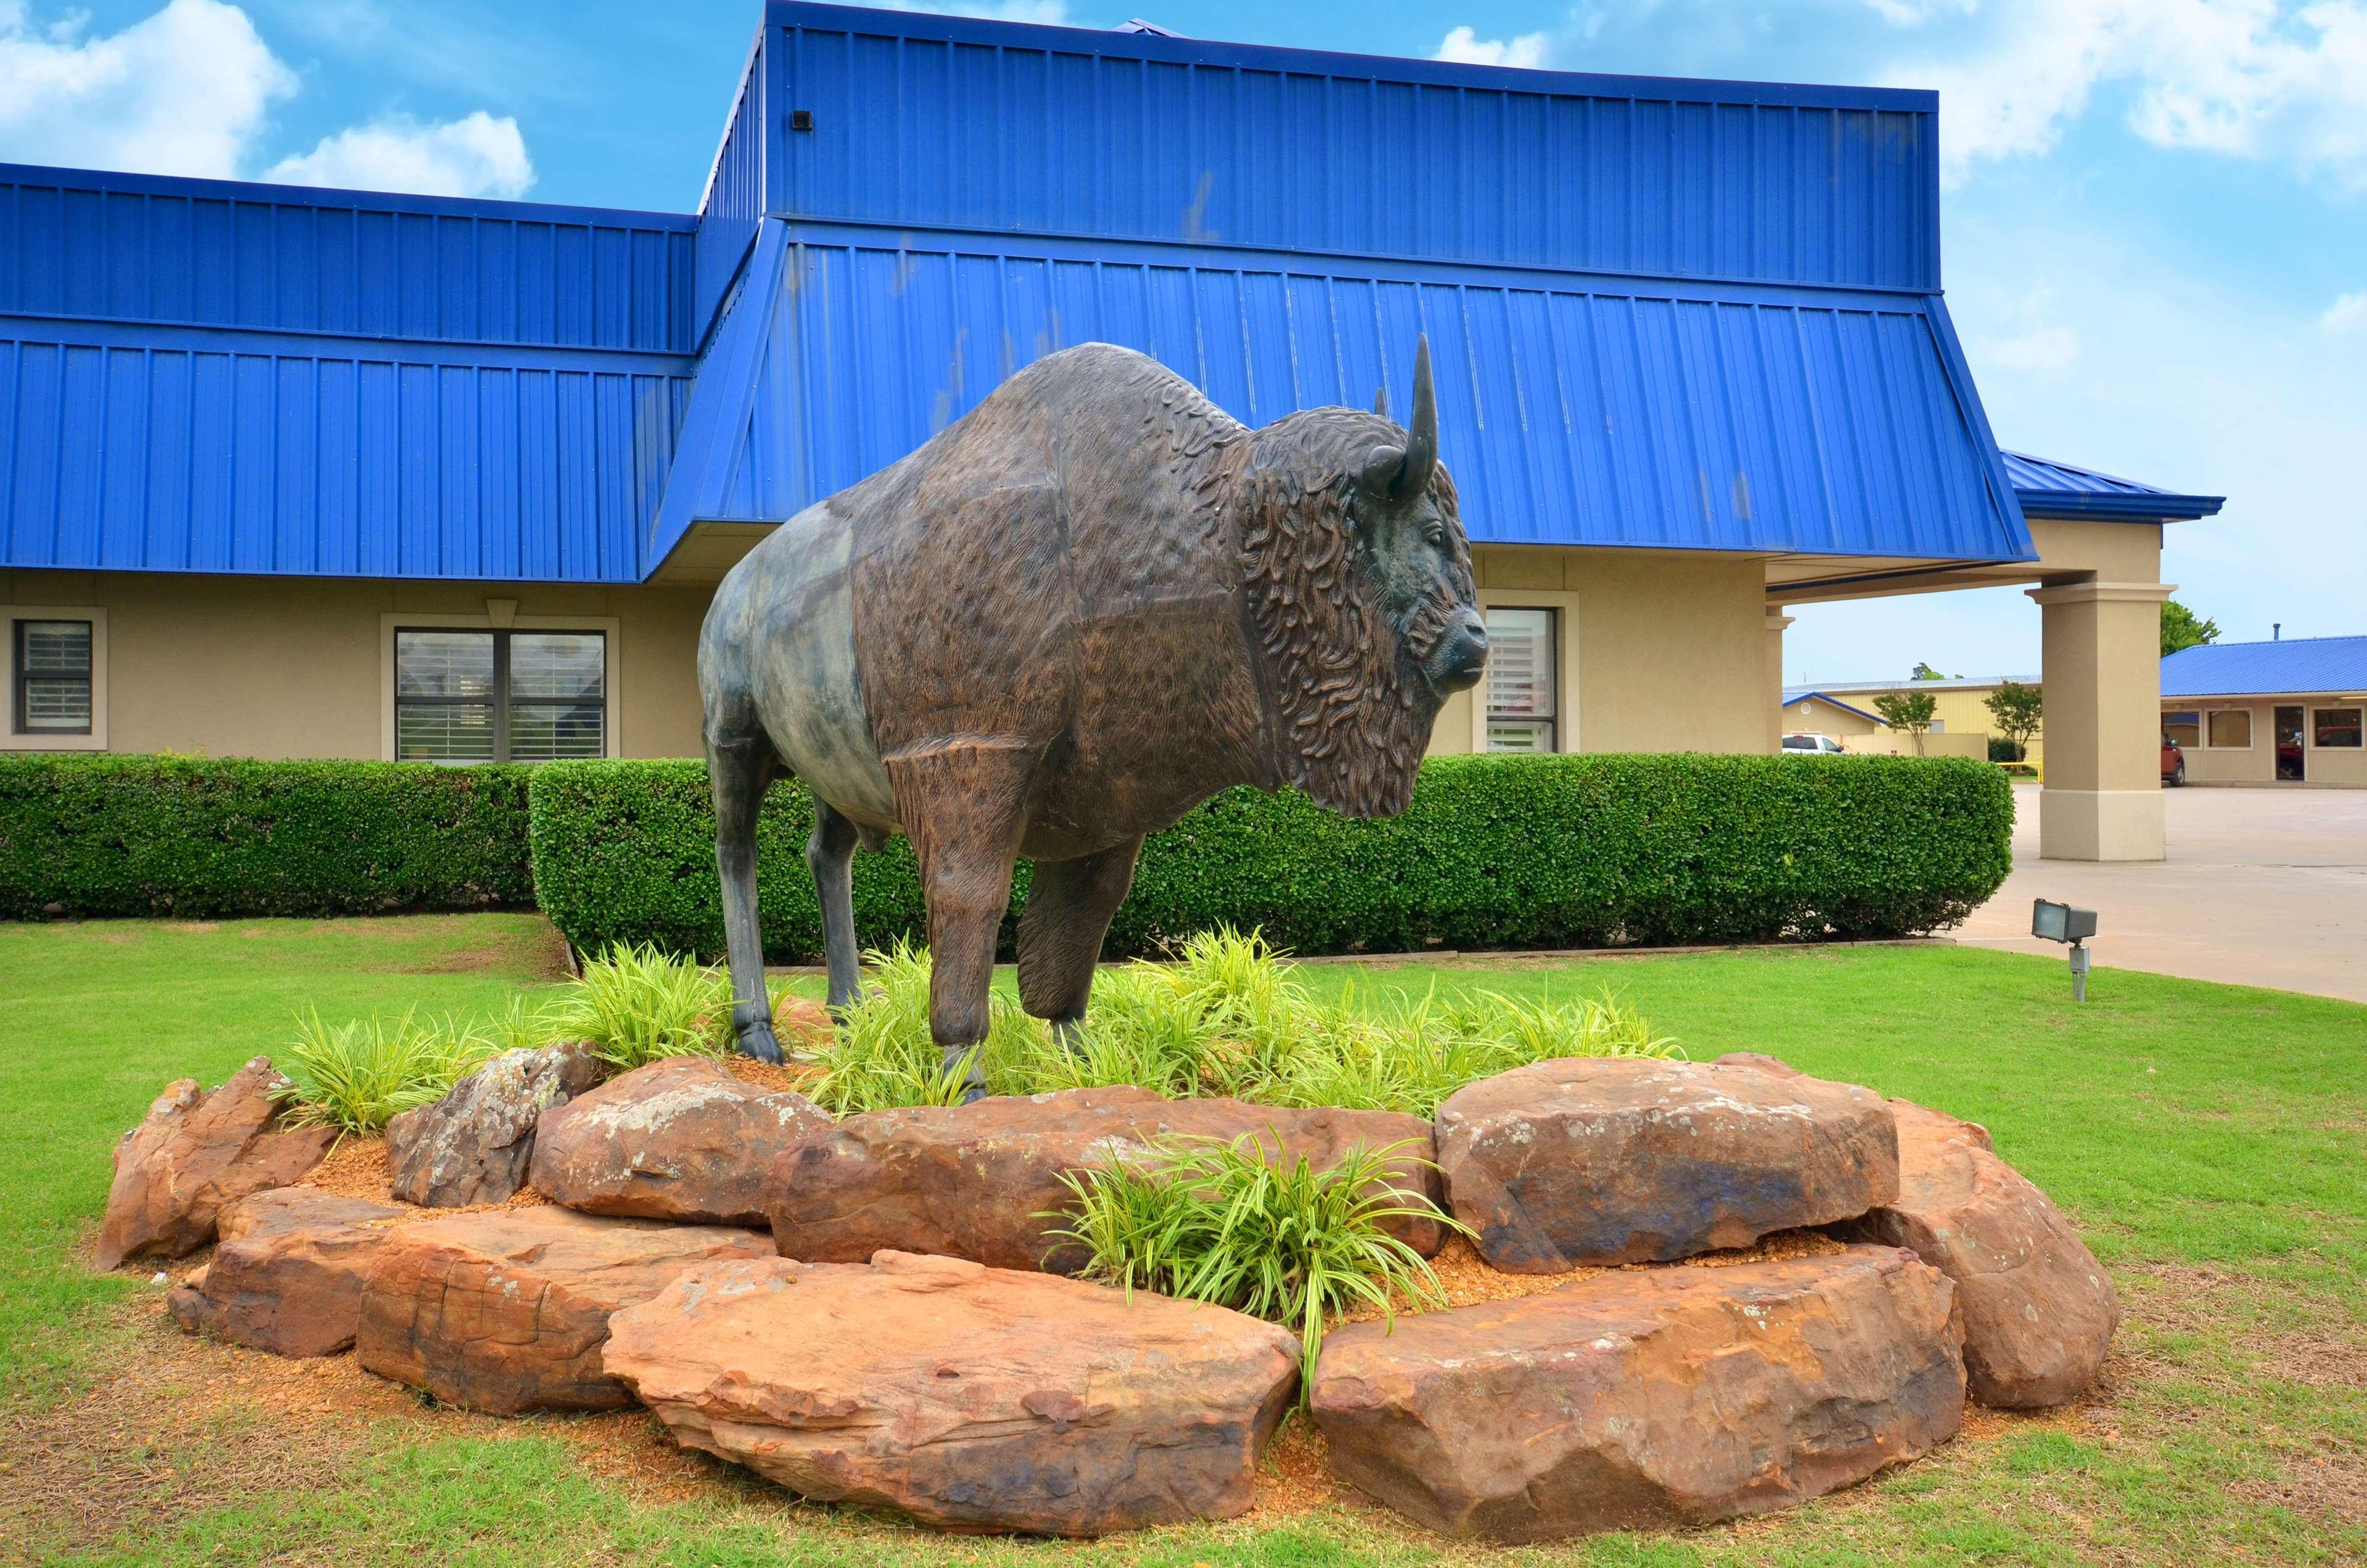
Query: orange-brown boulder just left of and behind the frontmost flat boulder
355 1205 772 1416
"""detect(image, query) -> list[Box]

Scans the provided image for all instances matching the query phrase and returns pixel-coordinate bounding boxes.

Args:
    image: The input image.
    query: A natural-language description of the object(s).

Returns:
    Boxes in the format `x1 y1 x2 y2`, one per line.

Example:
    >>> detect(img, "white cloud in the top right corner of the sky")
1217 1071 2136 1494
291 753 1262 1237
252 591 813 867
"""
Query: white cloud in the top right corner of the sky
1865 0 2367 187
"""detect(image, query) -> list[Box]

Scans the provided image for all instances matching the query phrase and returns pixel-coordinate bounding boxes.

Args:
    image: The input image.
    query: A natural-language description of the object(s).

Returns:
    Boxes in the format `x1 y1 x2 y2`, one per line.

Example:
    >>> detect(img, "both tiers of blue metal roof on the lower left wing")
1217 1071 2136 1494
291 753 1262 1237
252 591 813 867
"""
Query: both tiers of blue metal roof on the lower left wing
0 166 696 583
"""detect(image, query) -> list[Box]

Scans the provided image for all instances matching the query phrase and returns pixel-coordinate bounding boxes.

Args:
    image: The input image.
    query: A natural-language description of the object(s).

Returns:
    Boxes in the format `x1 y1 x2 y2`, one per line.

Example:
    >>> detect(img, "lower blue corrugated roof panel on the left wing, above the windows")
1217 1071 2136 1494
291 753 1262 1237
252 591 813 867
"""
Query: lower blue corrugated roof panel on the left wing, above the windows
0 318 689 583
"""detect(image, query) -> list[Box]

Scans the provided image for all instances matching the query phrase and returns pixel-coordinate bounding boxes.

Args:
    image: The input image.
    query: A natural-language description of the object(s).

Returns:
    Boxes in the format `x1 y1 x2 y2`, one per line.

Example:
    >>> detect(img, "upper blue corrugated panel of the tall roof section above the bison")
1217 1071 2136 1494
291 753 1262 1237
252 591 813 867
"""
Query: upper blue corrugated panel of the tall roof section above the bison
757 2 1938 289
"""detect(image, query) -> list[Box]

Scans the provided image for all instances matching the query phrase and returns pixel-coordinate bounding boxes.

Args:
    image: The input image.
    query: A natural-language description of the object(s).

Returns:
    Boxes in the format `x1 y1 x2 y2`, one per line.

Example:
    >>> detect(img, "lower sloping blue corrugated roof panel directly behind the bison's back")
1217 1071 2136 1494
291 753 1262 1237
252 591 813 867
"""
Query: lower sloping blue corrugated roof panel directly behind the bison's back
651 220 2031 561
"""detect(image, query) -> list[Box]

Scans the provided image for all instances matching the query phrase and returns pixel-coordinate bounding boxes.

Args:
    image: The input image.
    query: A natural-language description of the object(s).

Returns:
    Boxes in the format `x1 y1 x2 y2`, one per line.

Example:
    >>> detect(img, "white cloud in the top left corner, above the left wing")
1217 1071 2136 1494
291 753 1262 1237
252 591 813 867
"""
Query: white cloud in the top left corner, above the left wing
0 0 296 178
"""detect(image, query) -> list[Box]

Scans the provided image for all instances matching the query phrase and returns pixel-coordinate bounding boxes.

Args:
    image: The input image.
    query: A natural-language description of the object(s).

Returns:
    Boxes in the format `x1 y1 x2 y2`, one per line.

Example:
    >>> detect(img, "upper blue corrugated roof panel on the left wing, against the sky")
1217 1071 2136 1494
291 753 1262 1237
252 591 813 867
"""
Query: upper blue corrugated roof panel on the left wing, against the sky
0 163 699 353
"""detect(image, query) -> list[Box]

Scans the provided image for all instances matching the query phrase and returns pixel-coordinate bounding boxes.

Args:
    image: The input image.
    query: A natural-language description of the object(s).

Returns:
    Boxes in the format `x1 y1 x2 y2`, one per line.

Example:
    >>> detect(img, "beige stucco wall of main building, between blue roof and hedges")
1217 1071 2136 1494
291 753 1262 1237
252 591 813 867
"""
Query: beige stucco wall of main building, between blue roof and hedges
14 547 1775 758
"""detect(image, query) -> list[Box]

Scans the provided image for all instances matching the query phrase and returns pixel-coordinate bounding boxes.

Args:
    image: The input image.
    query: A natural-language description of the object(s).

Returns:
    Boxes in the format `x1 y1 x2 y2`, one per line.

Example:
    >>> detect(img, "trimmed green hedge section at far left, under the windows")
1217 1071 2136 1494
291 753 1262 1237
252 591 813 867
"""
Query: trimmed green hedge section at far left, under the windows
0 753 535 919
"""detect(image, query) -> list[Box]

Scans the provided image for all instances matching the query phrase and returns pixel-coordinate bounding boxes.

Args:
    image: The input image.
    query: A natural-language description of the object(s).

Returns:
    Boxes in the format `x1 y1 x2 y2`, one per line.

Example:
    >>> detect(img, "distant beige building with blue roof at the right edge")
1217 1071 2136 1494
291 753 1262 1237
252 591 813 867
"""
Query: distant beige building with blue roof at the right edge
2161 637 2367 789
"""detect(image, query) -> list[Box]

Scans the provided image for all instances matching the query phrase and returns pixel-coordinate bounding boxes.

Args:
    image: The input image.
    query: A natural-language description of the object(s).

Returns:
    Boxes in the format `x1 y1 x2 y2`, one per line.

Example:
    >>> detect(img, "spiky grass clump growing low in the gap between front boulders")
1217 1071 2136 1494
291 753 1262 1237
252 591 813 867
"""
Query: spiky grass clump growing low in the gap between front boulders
1053 1137 1470 1400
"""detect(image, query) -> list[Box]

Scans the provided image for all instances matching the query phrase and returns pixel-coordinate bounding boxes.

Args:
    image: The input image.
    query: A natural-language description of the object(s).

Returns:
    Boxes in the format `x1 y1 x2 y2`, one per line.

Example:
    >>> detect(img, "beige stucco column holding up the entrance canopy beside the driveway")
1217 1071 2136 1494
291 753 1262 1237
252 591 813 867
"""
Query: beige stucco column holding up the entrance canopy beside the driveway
2029 580 2175 860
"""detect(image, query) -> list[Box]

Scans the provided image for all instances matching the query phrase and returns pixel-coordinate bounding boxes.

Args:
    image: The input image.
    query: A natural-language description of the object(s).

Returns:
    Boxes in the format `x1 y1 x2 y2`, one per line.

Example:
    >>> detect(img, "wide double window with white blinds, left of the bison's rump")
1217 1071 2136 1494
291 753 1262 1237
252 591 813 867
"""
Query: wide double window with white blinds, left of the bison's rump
395 630 609 763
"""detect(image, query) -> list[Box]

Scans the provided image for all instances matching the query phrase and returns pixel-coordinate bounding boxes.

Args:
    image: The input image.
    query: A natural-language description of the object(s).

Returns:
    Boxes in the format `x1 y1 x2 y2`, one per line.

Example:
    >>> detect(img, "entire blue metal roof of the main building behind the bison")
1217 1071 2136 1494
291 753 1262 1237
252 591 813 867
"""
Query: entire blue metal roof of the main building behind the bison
0 0 2215 583
